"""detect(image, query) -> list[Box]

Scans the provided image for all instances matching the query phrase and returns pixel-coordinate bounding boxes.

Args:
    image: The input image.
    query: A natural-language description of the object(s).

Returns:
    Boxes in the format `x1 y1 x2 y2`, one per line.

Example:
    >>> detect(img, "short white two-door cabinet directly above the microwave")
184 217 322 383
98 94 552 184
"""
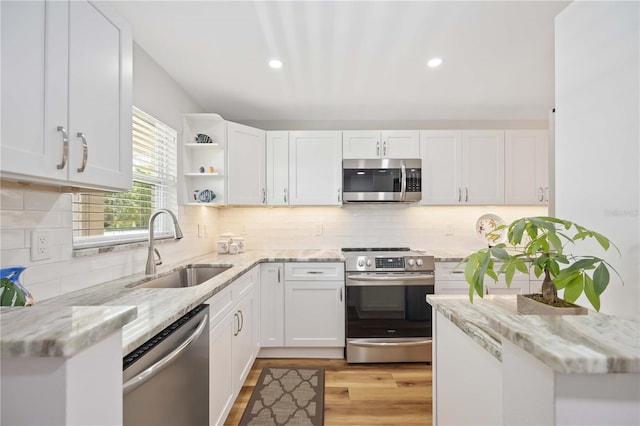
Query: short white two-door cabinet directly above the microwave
342 130 420 160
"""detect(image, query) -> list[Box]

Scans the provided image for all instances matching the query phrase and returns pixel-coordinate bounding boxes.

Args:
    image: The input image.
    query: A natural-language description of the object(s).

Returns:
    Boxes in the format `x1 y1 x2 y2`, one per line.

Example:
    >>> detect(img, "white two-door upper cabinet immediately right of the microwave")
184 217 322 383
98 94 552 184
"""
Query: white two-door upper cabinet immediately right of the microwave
420 130 504 205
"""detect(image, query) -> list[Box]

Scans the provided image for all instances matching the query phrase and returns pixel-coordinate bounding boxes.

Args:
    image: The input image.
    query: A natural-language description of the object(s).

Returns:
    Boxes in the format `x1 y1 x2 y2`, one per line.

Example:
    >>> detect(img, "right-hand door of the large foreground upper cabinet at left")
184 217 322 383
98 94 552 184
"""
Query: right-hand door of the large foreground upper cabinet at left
68 1 132 190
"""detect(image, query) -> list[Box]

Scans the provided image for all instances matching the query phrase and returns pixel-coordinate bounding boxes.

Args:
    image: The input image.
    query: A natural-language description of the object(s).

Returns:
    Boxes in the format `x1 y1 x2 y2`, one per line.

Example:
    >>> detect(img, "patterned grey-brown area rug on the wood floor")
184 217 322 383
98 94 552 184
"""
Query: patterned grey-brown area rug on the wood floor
240 367 324 426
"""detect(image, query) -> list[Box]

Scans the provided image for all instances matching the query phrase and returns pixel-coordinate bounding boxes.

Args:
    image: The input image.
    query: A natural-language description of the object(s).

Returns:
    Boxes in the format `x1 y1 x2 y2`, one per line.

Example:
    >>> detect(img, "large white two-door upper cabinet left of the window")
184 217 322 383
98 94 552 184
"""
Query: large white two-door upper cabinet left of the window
0 1 132 190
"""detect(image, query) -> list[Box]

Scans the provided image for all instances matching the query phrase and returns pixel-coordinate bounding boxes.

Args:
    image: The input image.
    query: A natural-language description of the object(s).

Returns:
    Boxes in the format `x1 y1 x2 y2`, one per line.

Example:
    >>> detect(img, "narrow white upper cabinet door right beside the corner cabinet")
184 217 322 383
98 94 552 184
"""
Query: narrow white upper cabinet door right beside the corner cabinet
267 132 289 206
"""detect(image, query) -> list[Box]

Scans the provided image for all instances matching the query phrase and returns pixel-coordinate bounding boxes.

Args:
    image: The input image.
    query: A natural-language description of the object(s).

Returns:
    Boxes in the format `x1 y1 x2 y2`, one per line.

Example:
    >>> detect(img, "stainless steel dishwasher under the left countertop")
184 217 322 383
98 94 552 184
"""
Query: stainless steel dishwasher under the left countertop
122 305 209 426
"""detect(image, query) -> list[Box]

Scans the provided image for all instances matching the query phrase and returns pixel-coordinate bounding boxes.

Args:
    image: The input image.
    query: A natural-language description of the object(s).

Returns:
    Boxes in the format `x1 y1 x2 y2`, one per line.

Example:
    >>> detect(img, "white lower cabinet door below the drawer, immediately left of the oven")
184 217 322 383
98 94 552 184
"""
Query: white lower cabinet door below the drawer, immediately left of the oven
284 281 345 347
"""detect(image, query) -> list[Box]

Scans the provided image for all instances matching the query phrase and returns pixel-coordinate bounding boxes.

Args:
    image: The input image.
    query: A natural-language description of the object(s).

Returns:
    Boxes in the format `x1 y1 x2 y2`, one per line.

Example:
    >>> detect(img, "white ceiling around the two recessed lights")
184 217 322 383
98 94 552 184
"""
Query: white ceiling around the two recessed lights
112 1 568 120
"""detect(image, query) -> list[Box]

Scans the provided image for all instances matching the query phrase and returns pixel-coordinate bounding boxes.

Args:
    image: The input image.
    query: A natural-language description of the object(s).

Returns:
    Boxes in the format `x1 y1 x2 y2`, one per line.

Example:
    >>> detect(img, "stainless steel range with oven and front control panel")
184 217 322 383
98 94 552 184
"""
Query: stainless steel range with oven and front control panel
342 247 435 363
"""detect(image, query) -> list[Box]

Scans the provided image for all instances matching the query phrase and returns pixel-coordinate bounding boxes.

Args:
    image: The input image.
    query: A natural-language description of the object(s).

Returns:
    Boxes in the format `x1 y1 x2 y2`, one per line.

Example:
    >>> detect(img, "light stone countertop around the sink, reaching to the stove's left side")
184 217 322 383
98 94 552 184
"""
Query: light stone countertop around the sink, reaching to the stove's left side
0 250 344 357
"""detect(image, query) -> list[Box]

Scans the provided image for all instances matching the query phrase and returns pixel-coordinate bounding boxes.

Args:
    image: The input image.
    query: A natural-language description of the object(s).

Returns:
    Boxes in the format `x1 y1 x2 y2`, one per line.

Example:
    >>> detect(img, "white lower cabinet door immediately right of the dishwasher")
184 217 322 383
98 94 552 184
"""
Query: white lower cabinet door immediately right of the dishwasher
209 312 236 426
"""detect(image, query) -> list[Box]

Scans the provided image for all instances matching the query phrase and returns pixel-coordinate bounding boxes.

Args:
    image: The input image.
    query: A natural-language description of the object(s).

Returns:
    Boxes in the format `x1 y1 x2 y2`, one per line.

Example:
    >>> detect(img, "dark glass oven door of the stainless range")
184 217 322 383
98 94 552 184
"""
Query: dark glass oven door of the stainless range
346 285 434 338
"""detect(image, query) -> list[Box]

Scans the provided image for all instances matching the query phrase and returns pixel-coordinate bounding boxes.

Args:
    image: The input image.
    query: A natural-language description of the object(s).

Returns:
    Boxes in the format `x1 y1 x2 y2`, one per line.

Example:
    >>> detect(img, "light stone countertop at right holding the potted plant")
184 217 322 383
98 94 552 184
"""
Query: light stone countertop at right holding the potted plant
427 295 640 374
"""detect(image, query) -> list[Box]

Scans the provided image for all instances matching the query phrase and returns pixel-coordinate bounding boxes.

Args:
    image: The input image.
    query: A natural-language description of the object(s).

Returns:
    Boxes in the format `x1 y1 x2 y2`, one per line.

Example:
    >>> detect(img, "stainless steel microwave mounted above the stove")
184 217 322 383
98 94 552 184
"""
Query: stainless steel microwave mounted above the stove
342 159 422 203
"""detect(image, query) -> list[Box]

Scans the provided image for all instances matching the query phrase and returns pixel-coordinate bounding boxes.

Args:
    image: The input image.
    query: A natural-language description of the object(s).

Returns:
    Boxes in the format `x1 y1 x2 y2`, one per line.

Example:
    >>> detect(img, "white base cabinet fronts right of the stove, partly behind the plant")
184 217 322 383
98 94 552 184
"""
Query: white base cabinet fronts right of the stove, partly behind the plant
435 262 530 295
